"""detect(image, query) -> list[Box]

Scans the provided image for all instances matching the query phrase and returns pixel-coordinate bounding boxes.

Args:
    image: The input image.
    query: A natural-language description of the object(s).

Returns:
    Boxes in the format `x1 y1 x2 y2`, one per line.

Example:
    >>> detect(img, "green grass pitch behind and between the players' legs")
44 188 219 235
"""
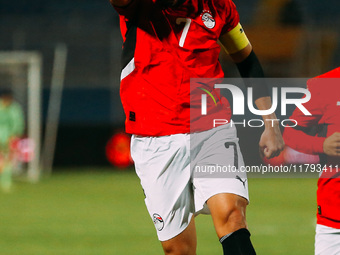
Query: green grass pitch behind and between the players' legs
0 169 317 255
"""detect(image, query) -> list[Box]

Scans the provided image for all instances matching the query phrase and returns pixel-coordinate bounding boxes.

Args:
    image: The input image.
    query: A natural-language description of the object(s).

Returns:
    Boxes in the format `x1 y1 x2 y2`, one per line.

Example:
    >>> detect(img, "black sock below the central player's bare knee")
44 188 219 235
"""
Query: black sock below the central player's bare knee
220 228 256 255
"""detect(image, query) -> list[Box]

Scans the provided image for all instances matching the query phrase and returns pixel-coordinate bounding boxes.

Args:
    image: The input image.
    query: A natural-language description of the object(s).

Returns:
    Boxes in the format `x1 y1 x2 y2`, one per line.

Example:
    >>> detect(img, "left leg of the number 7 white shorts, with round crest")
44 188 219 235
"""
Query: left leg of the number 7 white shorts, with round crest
131 134 194 241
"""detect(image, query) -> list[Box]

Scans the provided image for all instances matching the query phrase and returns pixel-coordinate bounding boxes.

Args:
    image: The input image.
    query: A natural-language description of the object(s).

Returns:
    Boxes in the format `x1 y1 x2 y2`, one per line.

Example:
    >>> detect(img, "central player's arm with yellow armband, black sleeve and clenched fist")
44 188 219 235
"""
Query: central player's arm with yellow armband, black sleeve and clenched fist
219 24 284 158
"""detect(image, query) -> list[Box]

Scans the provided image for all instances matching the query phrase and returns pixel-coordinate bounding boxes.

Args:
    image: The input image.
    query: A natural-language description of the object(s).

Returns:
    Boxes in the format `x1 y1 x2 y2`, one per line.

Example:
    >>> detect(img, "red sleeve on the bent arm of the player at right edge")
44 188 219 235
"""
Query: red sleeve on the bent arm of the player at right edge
283 79 326 154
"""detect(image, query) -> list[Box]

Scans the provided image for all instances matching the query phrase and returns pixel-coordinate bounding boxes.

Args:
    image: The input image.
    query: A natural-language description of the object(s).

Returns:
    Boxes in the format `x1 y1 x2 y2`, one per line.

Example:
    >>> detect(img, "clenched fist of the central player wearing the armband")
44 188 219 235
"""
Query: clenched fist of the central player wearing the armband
259 125 285 159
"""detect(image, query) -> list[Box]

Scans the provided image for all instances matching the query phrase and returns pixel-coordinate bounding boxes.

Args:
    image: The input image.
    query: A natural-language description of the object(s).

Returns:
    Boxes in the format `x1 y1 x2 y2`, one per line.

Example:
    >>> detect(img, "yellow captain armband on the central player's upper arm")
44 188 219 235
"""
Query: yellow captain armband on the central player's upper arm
219 23 249 54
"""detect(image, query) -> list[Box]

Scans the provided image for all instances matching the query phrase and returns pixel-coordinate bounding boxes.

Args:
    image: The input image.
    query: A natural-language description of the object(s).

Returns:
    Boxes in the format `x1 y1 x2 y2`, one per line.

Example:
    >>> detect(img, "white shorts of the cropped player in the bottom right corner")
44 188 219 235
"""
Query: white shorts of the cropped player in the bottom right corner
315 224 340 255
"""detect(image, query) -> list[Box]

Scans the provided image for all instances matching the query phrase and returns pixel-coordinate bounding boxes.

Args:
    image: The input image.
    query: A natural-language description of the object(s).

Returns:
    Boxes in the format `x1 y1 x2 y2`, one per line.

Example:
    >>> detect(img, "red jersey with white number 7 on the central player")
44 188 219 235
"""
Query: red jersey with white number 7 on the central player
115 0 239 136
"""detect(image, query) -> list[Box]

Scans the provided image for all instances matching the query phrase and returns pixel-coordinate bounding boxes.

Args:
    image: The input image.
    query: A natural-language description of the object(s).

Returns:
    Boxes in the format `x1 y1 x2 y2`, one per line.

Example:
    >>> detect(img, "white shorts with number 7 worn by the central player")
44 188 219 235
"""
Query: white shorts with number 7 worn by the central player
131 125 249 241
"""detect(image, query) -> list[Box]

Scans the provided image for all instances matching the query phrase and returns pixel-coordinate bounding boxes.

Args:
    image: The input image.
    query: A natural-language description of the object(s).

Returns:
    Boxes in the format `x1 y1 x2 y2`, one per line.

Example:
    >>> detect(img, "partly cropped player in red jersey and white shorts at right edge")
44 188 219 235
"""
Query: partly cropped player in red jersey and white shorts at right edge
284 67 340 255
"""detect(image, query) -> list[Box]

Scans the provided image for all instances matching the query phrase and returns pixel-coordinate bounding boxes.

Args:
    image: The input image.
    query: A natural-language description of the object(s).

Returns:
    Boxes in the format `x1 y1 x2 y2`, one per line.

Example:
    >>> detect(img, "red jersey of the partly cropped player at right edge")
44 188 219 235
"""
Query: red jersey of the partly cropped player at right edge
283 67 340 229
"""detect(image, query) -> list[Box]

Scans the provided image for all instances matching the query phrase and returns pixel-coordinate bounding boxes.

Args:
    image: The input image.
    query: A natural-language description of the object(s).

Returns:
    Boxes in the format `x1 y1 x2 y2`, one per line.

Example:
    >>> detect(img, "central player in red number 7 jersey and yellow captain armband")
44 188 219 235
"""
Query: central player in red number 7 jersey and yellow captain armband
110 0 284 255
